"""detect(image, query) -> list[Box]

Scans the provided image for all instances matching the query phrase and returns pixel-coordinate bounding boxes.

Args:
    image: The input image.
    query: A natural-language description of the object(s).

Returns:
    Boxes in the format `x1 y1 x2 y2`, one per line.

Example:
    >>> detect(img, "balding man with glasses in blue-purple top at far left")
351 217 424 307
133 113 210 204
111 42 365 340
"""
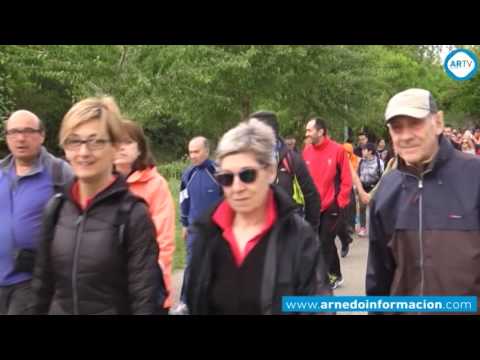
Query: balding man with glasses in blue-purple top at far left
0 110 73 315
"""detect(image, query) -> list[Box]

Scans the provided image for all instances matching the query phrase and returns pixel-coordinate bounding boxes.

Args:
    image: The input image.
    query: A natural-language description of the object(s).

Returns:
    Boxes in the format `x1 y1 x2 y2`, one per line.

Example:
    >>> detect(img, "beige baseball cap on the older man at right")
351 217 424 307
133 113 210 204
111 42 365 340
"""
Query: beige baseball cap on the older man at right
385 89 438 123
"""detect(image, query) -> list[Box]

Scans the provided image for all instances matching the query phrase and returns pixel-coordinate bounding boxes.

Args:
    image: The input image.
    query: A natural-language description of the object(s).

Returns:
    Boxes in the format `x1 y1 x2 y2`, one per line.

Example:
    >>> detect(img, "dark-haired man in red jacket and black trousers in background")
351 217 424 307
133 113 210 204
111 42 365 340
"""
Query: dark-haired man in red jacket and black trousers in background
303 118 352 289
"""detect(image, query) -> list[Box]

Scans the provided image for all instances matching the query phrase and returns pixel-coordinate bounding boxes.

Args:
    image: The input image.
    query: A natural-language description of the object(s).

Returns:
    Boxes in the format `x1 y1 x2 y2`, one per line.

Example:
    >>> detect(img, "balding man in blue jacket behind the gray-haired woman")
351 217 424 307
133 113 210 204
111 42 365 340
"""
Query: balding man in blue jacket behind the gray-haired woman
176 136 222 312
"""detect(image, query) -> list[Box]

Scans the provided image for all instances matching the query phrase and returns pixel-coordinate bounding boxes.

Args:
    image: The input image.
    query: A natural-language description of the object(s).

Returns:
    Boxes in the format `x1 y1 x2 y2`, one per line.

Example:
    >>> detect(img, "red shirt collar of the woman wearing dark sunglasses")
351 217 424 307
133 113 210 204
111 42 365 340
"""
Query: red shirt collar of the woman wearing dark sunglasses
212 190 277 267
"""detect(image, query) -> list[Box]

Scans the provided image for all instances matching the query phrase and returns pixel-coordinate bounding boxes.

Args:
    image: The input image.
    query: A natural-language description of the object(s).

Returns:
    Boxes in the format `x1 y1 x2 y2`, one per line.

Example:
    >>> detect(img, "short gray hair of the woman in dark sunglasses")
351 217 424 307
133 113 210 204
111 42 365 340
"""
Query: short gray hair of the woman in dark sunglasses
216 119 277 167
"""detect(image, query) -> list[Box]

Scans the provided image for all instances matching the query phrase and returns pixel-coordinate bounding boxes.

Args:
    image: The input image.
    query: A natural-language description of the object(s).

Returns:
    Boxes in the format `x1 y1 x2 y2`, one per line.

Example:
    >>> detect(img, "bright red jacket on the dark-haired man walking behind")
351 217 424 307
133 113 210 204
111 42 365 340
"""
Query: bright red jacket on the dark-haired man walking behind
303 137 352 212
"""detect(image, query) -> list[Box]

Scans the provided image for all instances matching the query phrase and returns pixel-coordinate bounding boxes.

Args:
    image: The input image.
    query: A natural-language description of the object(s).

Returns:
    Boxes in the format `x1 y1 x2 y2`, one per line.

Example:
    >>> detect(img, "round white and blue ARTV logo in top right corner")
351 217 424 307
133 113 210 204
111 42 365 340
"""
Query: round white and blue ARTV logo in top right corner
443 49 478 80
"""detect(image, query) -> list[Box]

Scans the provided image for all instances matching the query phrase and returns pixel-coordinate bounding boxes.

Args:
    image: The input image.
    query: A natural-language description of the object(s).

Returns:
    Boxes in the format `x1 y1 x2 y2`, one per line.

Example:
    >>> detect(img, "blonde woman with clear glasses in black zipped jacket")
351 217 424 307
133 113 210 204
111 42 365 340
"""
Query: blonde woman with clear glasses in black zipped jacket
32 97 162 315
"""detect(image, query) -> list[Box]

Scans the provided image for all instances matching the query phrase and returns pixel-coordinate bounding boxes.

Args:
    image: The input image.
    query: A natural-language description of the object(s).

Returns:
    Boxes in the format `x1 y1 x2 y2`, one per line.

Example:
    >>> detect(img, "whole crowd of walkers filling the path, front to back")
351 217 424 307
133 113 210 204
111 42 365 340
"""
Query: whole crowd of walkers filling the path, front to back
0 89 480 315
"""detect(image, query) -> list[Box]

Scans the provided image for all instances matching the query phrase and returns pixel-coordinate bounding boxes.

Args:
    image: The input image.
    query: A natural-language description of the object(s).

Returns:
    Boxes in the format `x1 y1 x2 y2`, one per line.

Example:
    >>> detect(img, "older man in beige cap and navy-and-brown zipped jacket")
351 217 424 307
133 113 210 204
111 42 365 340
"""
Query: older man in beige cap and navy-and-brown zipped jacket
366 89 480 312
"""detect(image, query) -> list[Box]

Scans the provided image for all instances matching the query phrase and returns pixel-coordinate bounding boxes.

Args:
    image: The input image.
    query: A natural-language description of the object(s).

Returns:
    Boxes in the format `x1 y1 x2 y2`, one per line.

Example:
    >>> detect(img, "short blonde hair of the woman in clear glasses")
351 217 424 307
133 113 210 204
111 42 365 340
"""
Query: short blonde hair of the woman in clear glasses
59 96 122 145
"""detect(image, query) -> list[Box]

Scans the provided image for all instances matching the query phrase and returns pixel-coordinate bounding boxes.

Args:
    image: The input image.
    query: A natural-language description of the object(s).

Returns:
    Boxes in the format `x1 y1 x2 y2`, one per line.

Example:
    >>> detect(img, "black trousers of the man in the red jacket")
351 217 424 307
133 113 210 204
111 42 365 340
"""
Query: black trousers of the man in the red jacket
318 205 342 277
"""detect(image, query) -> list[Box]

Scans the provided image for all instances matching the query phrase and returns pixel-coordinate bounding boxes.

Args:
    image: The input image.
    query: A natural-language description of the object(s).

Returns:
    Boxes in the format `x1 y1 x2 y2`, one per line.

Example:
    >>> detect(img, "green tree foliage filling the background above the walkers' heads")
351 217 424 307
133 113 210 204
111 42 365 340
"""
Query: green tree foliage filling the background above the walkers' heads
0 45 480 162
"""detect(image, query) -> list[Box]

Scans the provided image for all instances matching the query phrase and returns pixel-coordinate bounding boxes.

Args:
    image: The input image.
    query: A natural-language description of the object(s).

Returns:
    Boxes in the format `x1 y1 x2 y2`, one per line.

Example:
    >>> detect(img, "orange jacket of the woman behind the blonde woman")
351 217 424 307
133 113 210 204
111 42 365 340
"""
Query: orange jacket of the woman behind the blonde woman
127 167 175 308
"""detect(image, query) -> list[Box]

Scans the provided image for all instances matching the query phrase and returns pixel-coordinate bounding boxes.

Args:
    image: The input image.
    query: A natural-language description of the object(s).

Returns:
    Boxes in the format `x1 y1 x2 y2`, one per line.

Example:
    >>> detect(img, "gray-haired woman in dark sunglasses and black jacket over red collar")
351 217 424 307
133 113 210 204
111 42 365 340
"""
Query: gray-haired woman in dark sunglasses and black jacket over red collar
186 119 330 315
